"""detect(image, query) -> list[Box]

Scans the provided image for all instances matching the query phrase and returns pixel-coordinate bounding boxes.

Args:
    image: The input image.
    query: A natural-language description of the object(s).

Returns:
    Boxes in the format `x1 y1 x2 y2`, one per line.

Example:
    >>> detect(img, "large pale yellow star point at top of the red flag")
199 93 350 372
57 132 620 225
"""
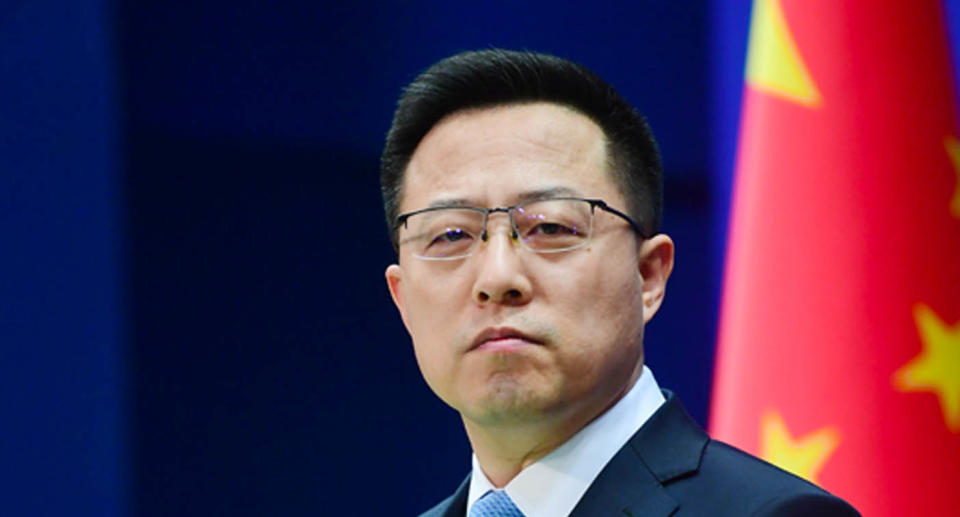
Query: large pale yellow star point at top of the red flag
746 0 821 107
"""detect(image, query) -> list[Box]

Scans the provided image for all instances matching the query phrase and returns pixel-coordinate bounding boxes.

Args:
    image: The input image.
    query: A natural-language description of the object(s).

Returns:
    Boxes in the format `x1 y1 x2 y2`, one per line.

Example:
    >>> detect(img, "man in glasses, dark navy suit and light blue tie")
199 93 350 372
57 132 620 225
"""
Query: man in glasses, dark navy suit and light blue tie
381 50 857 517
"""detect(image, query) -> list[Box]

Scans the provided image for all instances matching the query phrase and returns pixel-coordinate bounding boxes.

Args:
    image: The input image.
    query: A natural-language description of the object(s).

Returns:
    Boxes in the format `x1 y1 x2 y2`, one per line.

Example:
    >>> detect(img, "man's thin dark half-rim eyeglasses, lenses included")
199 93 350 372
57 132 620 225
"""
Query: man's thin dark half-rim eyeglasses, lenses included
397 197 647 260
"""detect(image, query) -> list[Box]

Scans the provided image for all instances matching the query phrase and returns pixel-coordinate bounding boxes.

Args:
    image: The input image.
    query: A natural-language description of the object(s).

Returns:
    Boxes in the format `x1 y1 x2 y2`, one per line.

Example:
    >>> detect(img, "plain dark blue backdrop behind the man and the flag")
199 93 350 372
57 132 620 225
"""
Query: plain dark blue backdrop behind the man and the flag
0 0 960 516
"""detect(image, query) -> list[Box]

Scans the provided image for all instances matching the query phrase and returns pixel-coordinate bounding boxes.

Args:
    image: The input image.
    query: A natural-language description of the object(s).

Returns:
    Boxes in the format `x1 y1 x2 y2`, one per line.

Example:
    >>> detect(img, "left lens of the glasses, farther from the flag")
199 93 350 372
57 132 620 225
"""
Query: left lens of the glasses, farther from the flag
400 208 483 260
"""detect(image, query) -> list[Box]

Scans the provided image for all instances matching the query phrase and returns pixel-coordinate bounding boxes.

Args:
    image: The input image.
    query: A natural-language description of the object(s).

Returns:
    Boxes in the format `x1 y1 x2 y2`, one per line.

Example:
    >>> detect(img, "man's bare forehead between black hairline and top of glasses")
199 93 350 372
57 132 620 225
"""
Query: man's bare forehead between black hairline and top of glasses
400 102 622 211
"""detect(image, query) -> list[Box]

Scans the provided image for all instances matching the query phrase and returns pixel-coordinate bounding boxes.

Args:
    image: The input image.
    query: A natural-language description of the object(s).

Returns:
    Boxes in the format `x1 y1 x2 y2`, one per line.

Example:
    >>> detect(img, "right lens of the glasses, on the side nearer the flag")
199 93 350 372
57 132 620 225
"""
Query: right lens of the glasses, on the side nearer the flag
513 199 593 253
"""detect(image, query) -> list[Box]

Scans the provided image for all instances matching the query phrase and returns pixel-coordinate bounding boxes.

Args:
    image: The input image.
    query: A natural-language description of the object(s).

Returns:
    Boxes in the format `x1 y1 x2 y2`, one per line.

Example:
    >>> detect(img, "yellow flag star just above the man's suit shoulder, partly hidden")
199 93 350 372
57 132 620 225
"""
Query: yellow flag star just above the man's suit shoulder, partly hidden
760 411 840 483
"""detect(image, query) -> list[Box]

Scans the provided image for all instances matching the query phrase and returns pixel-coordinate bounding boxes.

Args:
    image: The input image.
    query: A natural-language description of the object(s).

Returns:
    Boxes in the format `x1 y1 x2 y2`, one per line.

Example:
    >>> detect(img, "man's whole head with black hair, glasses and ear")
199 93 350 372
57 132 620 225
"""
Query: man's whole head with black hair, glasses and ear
383 51 673 436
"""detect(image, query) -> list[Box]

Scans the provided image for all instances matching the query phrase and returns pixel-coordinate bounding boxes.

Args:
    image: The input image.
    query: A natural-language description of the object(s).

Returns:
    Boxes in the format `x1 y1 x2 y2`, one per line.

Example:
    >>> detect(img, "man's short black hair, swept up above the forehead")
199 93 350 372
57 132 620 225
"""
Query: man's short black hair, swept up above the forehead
380 49 663 245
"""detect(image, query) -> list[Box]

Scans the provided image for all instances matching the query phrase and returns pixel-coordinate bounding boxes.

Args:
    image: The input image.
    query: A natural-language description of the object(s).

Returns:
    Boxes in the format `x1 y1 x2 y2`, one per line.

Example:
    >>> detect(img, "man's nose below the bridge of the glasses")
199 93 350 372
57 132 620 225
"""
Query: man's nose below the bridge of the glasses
473 219 533 305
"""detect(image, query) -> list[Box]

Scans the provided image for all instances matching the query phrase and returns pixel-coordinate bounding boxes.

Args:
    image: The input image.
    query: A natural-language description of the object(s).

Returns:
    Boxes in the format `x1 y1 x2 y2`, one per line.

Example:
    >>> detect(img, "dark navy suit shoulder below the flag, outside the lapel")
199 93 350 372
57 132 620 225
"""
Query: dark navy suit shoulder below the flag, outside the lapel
671 440 859 517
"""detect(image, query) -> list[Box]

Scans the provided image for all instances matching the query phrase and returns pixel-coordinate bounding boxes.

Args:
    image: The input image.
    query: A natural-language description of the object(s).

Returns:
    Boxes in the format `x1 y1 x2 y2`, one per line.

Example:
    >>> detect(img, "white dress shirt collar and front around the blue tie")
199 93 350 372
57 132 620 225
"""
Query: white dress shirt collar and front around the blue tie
467 365 665 517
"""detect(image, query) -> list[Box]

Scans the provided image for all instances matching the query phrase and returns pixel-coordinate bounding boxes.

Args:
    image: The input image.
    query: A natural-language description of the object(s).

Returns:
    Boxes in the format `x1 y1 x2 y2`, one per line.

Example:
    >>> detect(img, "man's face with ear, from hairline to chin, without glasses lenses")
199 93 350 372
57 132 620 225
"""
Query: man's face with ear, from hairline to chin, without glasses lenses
386 103 672 432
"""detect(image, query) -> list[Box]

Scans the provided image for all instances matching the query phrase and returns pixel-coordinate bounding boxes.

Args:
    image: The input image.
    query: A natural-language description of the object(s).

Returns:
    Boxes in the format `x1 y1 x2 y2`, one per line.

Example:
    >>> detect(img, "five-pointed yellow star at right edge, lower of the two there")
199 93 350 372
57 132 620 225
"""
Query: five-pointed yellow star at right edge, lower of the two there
893 304 960 432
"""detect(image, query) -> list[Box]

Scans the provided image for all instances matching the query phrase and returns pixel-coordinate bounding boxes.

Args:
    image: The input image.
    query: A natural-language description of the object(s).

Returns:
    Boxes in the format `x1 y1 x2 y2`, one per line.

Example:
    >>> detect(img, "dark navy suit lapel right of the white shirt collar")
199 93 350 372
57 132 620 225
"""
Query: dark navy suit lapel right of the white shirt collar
570 391 709 517
